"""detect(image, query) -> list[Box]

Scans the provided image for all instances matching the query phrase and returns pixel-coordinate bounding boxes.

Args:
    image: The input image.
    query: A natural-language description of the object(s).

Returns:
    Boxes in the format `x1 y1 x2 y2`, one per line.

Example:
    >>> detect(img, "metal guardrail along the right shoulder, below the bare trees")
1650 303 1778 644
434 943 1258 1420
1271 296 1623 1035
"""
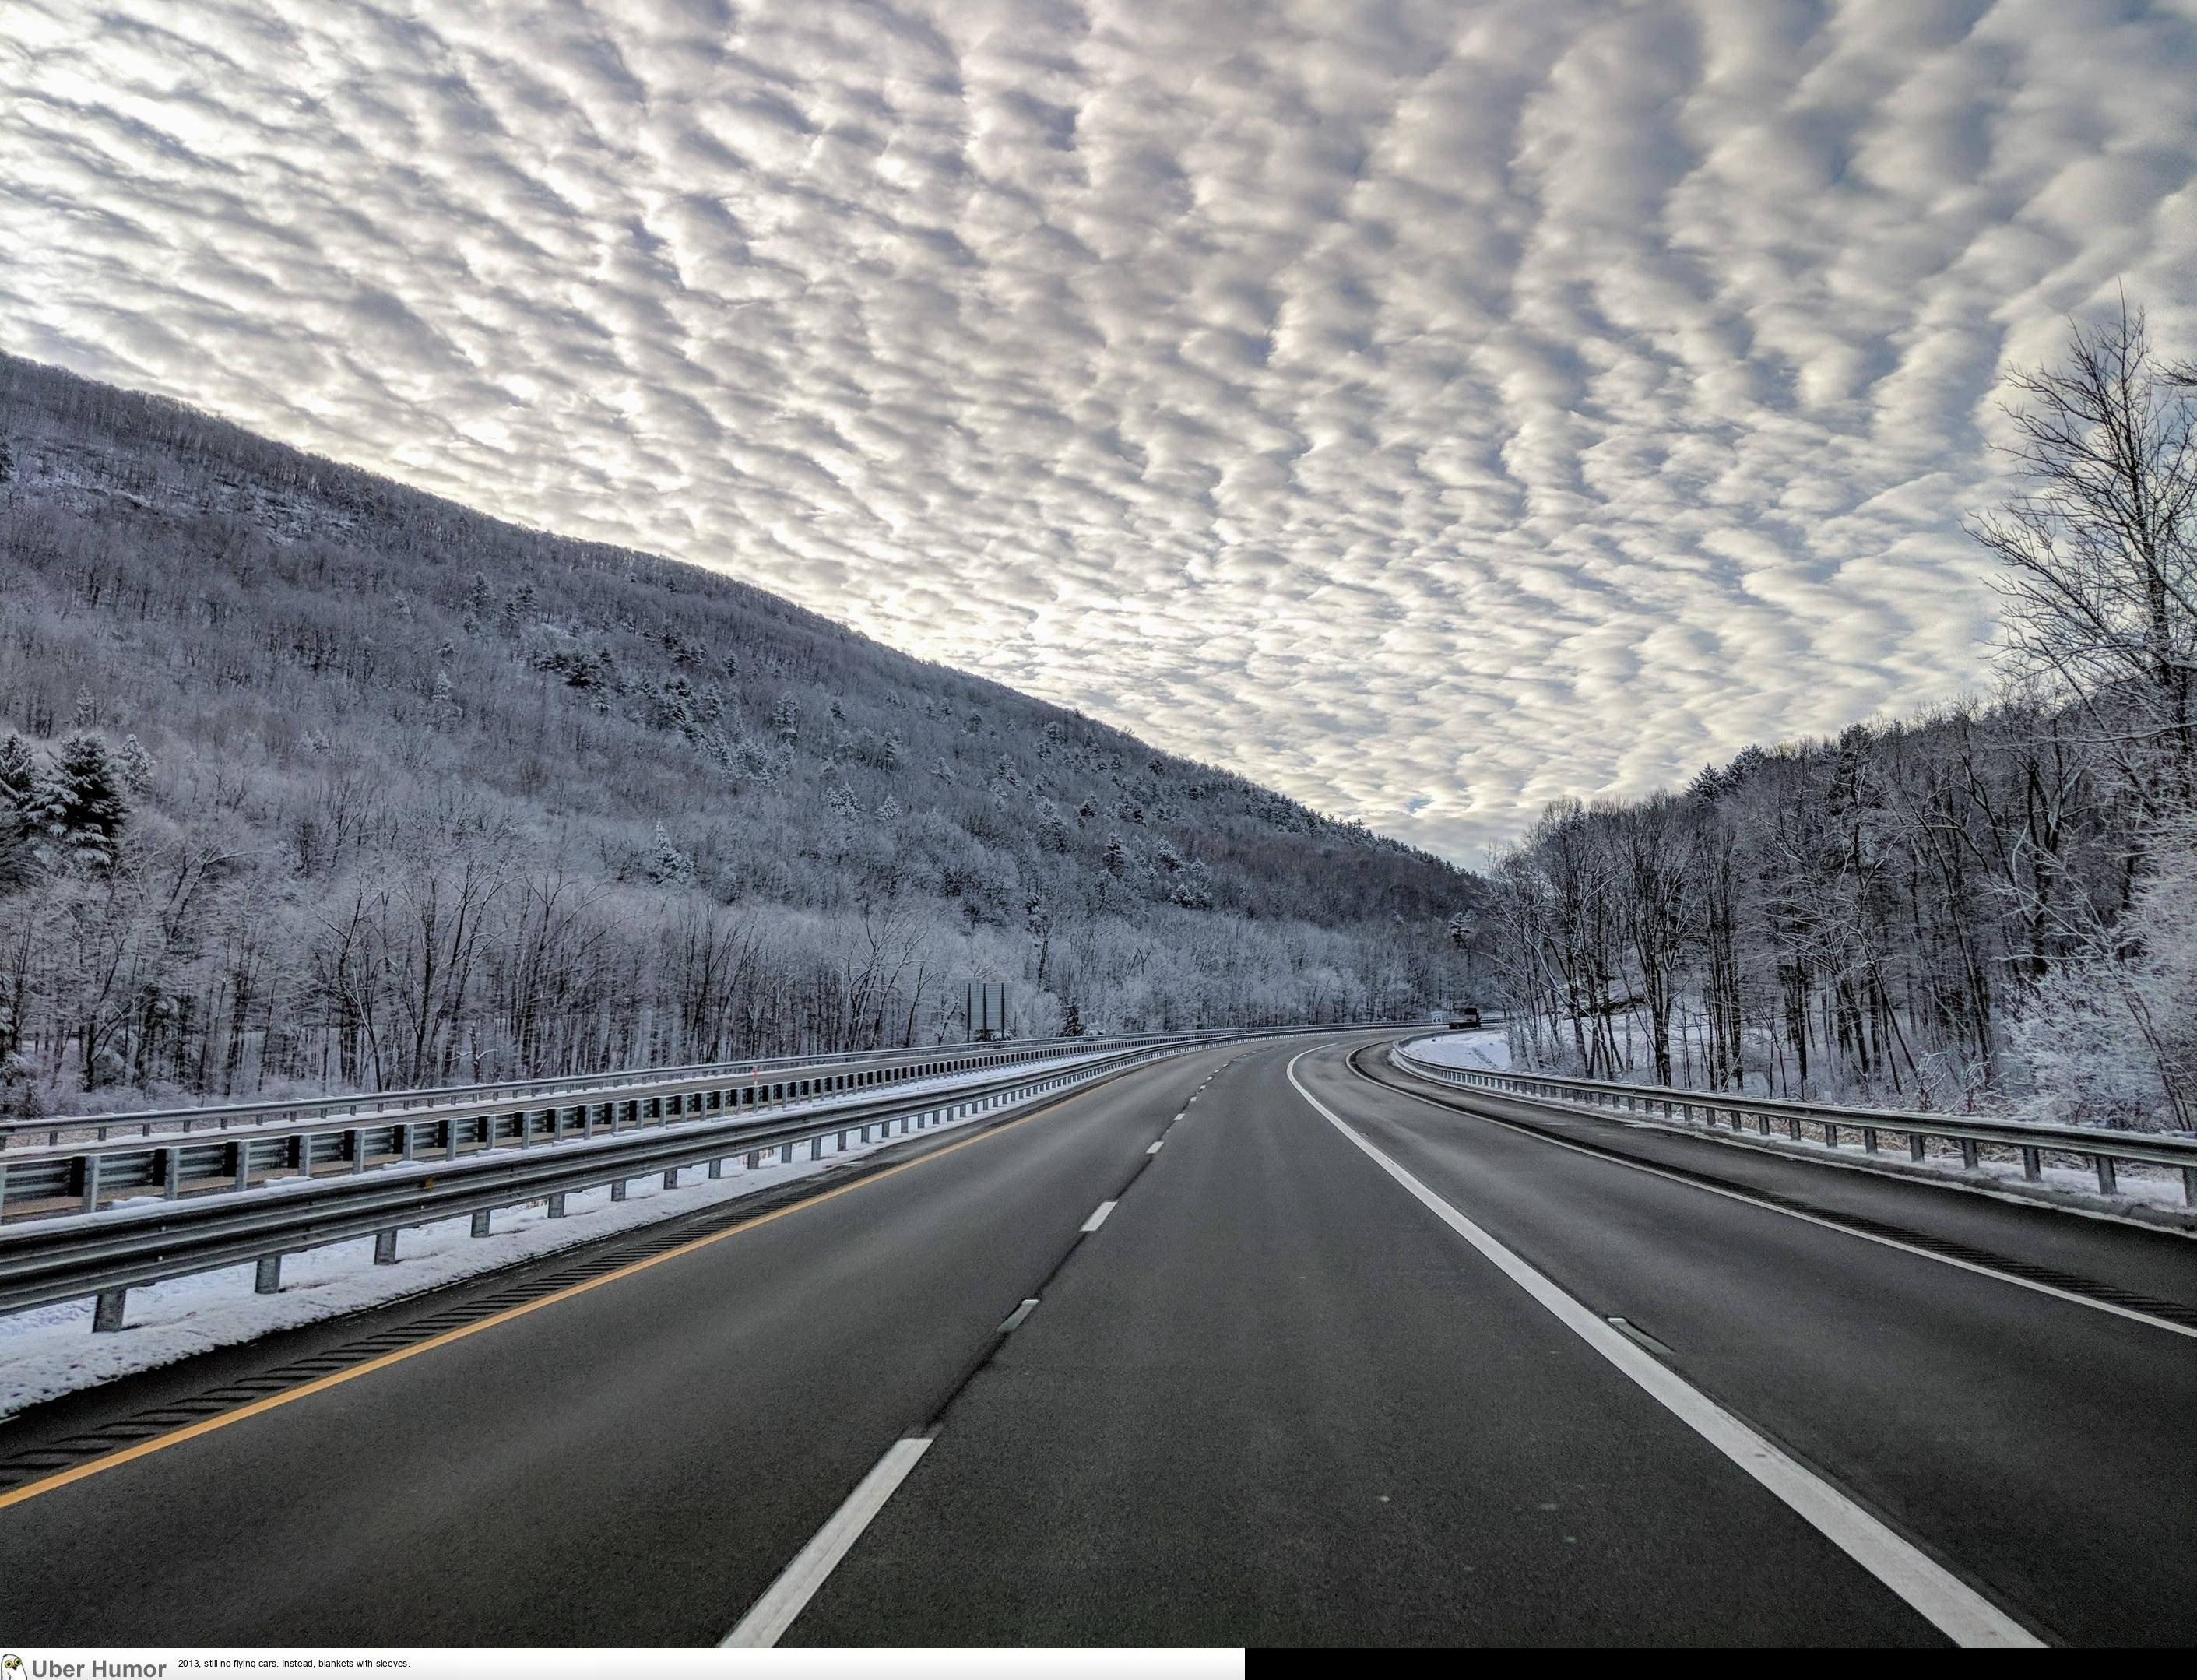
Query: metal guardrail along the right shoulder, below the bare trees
1389 1039 2197 1206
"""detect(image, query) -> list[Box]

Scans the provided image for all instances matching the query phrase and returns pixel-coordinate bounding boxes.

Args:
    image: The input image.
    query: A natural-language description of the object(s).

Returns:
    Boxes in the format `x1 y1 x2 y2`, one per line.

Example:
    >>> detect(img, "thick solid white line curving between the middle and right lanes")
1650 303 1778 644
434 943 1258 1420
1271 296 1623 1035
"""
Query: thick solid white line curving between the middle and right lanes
1288 1049 2043 1650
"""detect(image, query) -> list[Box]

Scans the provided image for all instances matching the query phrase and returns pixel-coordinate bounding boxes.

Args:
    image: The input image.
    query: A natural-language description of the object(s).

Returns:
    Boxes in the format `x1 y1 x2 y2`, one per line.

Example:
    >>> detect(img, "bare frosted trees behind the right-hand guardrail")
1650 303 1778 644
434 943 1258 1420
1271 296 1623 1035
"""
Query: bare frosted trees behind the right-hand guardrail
1485 314 2197 1129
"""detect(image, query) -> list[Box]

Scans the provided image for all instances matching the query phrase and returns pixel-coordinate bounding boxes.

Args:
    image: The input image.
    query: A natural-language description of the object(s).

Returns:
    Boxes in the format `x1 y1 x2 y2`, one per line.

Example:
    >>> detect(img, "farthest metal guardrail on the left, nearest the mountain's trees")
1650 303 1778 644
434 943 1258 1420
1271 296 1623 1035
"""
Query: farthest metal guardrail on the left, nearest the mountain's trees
0 1021 1309 1151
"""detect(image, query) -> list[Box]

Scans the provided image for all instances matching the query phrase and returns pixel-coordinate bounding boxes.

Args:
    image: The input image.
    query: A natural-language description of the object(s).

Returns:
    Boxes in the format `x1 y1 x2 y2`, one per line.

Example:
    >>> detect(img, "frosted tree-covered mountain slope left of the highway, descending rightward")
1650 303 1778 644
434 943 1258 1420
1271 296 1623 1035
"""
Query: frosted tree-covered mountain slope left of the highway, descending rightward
0 358 1481 1107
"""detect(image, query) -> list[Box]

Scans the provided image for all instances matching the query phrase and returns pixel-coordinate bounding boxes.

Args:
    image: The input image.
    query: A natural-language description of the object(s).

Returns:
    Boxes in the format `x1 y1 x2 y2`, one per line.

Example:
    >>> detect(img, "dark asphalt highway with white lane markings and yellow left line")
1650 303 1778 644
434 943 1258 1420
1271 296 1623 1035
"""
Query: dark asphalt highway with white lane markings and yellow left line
0 1035 2197 1647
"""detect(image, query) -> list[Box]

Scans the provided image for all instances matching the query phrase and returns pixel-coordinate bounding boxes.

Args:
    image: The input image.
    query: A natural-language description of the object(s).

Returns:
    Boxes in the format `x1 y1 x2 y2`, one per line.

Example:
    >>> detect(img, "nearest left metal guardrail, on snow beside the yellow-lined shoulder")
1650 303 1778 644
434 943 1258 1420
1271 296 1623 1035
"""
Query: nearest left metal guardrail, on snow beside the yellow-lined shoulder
0 1028 1370 1330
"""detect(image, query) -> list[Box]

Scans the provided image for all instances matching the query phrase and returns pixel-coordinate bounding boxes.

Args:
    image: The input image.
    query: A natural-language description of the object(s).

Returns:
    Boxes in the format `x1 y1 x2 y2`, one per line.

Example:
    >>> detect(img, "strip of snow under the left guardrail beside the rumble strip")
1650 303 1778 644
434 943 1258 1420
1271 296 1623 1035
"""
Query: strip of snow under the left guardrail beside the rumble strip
0 1063 1098 1405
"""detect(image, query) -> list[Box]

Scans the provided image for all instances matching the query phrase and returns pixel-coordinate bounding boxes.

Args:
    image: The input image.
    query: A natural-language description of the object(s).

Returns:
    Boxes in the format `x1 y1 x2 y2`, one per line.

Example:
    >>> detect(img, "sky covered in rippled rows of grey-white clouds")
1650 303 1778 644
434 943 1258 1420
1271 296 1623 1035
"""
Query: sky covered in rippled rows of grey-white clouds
0 0 2197 861
